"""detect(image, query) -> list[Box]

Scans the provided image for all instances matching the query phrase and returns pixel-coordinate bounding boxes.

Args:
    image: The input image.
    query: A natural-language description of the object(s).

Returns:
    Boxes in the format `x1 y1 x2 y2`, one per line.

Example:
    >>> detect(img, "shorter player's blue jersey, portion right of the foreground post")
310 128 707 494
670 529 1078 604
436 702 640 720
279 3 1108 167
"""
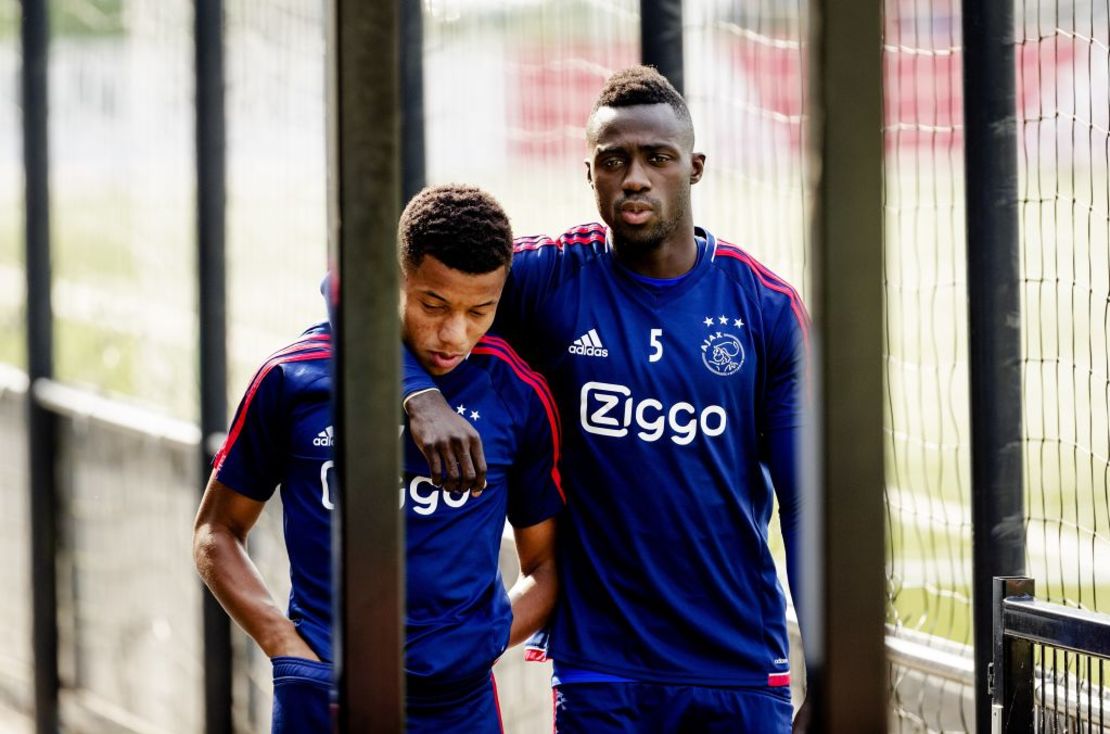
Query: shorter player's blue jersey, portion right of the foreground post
401 336 564 691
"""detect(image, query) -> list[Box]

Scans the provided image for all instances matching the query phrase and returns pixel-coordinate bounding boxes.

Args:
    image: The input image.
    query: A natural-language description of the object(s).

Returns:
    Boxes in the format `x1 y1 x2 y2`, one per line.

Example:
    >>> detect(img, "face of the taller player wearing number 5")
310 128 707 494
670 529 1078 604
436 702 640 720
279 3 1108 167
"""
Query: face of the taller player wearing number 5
586 104 705 248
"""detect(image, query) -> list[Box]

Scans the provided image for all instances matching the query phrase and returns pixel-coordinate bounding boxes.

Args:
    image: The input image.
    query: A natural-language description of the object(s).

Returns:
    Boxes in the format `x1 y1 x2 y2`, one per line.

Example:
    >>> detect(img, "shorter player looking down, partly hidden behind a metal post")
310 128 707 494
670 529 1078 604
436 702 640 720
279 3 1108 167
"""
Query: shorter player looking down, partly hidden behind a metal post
193 185 564 734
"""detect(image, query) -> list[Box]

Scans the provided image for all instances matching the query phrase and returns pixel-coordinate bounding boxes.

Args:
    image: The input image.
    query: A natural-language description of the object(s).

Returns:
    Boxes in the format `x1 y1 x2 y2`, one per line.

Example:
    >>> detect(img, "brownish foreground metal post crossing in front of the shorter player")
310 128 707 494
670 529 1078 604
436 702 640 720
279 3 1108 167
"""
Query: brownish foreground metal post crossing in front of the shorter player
327 0 404 734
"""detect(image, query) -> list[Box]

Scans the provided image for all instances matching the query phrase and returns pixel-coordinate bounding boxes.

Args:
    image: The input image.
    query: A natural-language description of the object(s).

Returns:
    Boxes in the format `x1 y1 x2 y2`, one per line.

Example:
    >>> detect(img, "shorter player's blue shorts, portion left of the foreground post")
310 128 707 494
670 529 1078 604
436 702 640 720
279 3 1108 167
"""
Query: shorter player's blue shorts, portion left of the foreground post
270 655 332 734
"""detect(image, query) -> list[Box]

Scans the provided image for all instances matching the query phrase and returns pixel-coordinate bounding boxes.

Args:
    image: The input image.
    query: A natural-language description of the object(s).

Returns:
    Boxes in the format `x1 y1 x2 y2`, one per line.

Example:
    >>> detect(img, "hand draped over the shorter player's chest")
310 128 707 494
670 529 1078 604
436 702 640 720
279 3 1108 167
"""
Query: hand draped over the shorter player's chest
405 390 486 496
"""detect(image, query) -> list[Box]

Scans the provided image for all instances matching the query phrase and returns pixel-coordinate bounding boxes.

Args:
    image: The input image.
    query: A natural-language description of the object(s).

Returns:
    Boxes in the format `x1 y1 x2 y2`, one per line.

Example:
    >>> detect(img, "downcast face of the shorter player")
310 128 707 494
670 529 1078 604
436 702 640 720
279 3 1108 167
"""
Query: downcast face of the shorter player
401 255 508 375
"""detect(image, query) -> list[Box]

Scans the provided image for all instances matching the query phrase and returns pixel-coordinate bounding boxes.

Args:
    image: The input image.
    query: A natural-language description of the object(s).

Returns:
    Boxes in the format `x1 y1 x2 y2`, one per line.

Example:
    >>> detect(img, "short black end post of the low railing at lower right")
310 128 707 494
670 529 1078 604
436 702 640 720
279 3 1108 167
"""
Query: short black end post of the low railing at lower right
994 576 1034 734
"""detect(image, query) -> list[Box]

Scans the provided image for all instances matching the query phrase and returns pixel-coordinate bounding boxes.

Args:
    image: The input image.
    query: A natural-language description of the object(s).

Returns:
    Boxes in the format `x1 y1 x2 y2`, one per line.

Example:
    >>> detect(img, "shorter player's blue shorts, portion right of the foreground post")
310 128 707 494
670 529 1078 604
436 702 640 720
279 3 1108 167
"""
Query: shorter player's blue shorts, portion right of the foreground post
405 673 505 734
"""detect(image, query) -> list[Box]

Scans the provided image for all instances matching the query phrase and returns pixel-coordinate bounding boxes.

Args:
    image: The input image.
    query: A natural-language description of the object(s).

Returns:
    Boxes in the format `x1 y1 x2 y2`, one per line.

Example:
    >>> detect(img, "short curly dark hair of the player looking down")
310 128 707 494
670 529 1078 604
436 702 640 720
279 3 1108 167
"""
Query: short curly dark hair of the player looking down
397 183 513 275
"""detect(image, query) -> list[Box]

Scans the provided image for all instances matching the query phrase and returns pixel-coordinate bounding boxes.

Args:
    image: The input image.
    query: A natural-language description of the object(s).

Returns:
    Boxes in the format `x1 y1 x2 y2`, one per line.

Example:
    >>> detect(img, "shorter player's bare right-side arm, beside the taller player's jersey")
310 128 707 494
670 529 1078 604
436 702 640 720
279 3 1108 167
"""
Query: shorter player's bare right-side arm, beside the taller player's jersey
508 517 558 646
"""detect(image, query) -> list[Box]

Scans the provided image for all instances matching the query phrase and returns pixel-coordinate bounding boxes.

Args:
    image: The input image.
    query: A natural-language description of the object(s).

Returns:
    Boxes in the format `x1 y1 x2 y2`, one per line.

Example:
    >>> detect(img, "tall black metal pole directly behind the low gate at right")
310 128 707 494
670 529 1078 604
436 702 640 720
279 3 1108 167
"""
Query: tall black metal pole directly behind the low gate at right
963 0 1025 732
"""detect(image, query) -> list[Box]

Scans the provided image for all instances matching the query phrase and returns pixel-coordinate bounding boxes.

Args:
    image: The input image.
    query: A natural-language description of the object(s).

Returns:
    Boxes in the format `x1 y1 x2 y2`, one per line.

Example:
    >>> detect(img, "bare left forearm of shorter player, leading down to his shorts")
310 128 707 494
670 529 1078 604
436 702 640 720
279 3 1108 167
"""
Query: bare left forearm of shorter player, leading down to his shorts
193 525 316 658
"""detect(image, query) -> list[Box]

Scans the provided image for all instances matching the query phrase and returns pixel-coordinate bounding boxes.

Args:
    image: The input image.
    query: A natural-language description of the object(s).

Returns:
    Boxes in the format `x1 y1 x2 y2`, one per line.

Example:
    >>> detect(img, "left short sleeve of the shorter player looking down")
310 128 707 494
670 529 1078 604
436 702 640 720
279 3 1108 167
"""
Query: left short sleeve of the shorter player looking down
215 364 289 502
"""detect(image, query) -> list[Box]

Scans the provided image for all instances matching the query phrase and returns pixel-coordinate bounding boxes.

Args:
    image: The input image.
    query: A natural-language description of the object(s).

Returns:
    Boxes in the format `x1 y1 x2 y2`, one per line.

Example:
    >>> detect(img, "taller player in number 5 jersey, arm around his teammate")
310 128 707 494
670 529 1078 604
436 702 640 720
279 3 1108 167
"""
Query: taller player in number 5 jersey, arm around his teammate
405 67 808 734
